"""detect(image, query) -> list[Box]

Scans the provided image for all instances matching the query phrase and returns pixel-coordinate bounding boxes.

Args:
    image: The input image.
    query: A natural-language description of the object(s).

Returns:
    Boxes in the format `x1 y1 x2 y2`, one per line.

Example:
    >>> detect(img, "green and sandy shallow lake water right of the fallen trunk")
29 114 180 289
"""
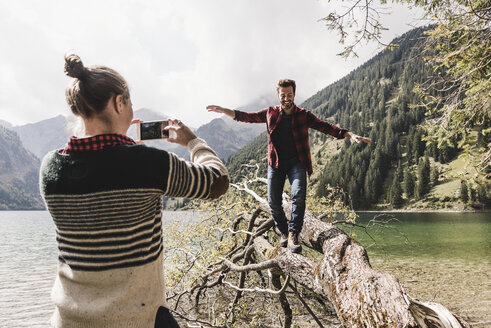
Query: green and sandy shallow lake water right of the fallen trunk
354 213 491 327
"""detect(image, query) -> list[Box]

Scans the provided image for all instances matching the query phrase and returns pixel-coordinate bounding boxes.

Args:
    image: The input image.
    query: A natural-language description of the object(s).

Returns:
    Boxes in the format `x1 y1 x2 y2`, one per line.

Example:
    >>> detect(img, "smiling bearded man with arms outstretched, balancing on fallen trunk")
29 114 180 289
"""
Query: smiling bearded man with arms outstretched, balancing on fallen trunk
206 79 371 253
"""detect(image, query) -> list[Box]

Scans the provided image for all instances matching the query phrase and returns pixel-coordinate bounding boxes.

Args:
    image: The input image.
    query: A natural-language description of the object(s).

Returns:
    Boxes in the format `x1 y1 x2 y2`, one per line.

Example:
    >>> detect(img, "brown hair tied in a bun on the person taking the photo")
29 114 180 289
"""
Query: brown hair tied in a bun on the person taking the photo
65 54 130 117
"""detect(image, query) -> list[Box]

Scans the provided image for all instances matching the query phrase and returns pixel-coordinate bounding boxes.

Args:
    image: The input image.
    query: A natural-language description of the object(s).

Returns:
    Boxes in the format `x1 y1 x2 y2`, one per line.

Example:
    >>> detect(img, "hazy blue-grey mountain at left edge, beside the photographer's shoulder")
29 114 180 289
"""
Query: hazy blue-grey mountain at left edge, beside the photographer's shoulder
0 126 44 210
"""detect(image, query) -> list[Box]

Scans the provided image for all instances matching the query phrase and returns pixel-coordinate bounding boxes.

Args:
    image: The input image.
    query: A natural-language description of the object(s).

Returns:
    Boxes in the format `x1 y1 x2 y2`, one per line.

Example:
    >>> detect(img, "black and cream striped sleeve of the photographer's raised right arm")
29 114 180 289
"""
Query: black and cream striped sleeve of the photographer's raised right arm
164 138 229 199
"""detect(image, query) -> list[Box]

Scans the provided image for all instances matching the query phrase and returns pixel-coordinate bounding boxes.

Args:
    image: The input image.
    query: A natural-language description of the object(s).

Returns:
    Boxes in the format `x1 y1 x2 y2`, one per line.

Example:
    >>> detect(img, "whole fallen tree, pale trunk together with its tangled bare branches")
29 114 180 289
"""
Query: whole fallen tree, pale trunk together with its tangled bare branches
170 177 470 328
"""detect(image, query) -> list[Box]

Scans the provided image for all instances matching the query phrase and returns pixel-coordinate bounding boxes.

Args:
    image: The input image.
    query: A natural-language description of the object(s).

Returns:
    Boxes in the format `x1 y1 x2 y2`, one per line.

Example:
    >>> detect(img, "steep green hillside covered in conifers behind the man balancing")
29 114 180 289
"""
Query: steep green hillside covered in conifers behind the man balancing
227 28 487 209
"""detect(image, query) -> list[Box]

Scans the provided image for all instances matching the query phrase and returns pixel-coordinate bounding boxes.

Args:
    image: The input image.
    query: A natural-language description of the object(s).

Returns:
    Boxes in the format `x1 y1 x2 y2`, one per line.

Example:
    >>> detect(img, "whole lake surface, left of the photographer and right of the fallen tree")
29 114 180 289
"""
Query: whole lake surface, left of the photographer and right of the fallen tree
0 211 491 328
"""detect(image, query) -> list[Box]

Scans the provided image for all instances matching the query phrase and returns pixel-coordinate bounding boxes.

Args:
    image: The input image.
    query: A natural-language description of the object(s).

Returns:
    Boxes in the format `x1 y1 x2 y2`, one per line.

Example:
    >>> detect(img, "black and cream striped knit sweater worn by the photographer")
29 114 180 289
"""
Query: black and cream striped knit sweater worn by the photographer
40 139 228 328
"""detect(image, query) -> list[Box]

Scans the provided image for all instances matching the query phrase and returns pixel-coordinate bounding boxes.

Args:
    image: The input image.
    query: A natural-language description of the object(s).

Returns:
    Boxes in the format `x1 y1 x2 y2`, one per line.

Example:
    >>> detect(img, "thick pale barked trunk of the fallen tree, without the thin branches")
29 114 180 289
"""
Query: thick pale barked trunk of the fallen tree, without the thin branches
225 178 470 328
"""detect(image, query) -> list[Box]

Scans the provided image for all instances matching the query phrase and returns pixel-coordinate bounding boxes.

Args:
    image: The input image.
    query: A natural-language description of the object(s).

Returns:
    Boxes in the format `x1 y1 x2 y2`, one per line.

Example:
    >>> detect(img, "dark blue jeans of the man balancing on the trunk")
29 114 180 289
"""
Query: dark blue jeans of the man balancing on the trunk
268 158 307 233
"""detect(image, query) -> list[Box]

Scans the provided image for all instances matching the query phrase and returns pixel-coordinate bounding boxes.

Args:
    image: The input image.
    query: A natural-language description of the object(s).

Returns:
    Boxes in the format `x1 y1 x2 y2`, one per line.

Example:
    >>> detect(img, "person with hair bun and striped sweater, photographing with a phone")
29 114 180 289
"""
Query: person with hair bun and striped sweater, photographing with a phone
40 54 229 328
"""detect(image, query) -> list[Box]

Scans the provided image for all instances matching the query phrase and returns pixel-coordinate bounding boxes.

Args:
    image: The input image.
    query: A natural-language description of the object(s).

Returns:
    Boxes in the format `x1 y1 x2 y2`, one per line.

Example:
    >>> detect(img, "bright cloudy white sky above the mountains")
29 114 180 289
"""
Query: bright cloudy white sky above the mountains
0 0 421 127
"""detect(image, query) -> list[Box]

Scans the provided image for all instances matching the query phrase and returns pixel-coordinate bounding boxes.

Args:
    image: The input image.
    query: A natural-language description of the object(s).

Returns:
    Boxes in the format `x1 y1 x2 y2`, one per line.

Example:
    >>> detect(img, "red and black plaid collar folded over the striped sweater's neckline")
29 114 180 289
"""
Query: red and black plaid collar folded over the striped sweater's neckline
59 133 136 155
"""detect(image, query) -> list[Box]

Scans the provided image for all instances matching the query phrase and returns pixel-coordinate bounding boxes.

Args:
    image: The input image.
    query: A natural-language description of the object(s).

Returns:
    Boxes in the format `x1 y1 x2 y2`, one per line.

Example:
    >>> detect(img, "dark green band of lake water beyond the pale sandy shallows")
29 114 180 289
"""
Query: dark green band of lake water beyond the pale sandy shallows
355 213 491 261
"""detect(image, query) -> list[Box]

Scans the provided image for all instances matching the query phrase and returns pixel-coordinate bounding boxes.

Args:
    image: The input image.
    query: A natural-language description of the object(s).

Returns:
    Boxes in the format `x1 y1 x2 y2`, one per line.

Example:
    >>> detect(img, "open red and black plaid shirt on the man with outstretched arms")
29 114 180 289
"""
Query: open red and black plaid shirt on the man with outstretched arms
235 106 348 175
